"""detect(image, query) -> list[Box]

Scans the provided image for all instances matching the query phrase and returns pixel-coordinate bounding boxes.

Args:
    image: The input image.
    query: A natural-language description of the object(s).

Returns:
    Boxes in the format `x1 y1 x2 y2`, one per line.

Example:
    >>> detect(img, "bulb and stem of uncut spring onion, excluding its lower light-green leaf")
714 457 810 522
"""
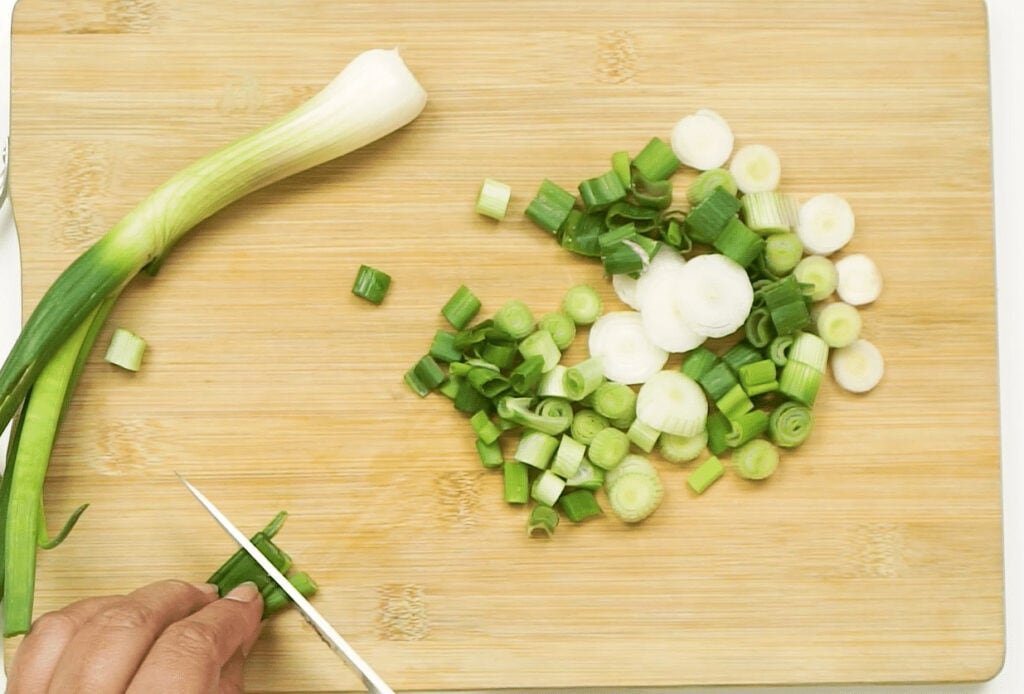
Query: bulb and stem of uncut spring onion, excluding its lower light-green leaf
0 50 426 440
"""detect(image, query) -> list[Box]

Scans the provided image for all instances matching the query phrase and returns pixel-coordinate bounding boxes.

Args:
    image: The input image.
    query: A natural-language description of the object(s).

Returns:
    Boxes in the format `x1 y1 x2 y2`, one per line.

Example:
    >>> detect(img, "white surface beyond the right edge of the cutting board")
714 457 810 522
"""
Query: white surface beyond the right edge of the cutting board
0 0 1024 694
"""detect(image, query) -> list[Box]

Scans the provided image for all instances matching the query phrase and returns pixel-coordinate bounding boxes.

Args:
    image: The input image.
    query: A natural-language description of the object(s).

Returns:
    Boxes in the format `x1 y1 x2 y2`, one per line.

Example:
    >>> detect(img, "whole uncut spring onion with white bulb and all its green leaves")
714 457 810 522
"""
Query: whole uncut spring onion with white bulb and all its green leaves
0 49 427 634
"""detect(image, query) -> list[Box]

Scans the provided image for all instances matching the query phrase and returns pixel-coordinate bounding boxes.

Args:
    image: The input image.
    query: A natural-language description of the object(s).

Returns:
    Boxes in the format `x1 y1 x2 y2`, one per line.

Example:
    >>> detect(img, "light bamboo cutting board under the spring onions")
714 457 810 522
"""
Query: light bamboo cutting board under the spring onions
7 0 1004 691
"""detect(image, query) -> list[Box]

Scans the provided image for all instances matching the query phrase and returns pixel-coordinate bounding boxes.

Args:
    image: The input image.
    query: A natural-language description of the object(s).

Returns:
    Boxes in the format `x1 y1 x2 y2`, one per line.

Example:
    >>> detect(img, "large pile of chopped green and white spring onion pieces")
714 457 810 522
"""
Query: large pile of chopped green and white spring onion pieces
415 110 884 534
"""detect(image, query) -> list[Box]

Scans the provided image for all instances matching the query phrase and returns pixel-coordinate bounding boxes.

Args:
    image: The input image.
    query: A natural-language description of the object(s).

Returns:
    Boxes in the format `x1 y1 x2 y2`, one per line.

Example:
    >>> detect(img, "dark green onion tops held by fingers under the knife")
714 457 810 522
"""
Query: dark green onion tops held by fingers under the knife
206 511 316 619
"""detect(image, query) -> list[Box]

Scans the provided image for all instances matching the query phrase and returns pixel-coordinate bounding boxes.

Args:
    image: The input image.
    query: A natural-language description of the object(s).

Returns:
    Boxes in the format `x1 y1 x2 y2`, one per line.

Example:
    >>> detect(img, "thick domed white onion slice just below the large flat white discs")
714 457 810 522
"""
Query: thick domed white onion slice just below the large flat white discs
637 371 708 436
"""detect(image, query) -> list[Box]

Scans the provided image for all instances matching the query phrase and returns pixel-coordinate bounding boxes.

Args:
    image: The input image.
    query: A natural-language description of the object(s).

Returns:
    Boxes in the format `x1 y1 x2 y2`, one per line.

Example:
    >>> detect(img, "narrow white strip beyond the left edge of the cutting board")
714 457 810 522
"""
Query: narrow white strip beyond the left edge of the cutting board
0 0 22 471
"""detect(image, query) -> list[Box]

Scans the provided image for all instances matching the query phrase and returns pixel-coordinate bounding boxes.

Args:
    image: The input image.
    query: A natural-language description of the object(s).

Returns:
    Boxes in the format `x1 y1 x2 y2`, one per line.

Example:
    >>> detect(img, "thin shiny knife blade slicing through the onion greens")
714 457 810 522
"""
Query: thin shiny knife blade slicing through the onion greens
178 475 393 694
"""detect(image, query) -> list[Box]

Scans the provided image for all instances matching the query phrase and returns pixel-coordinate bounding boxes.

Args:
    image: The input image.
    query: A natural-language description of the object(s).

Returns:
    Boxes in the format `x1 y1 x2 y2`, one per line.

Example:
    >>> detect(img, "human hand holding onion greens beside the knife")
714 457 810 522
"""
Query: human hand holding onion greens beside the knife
7 580 263 694
